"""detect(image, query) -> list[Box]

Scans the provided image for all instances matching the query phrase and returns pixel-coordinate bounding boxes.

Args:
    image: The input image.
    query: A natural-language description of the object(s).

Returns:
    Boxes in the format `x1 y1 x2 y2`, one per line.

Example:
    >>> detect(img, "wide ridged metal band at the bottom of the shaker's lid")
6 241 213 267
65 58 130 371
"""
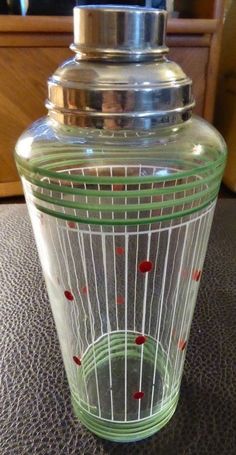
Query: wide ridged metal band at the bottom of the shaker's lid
46 79 194 129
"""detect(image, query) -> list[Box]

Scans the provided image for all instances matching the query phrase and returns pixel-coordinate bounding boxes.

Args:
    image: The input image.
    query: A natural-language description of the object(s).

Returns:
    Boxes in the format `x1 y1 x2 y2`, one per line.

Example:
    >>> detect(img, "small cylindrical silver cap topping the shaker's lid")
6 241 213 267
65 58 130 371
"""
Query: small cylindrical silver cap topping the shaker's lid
71 6 168 61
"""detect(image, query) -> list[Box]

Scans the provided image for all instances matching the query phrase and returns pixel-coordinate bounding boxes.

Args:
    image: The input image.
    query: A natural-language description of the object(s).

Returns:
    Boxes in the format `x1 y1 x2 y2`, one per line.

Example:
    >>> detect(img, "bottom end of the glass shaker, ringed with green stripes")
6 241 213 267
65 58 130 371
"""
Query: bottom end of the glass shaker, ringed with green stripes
69 331 179 442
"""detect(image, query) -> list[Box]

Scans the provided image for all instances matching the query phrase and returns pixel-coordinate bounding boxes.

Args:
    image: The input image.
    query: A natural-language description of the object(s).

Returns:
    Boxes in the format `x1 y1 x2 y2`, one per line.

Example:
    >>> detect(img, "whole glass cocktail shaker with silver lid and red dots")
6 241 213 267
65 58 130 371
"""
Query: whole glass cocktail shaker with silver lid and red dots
16 7 226 441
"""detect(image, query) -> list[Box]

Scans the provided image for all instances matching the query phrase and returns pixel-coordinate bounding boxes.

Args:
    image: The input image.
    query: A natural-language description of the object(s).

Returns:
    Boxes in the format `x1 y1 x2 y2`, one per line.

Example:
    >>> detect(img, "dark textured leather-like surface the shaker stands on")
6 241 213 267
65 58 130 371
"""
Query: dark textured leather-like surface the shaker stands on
0 203 236 455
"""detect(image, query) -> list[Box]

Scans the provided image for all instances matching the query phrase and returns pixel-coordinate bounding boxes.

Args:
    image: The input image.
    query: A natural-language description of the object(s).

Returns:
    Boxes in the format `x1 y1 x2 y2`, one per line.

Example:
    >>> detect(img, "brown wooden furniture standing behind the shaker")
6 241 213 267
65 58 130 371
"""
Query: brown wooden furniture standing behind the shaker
0 0 224 197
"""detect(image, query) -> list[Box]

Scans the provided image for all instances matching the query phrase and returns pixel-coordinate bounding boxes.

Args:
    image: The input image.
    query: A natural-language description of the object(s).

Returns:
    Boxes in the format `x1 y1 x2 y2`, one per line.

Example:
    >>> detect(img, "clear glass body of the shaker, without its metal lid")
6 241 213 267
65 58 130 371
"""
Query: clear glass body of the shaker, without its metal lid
16 117 226 441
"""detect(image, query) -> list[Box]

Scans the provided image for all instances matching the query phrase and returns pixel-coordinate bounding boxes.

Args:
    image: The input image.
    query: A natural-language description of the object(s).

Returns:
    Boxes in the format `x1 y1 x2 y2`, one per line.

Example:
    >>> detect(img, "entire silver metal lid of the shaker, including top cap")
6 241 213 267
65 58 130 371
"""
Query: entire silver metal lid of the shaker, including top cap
46 6 194 129
